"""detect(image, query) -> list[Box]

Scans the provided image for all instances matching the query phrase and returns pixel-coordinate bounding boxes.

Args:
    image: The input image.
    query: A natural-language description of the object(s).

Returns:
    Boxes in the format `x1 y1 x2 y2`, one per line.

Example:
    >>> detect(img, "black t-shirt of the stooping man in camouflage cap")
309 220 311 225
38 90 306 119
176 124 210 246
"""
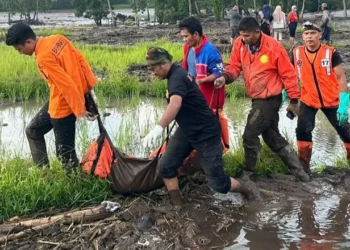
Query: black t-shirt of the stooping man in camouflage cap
167 64 221 143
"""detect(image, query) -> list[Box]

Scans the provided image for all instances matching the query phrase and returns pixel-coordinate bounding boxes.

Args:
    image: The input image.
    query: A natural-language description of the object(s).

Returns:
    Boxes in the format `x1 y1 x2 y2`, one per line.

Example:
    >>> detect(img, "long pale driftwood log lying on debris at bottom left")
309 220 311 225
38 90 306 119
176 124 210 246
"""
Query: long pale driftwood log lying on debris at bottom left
0 206 108 237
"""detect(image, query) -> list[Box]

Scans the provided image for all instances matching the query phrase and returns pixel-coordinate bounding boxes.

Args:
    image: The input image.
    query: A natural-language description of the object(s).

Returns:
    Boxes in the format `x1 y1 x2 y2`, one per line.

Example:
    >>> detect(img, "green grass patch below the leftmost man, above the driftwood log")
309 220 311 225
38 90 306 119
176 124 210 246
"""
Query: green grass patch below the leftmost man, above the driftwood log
0 155 111 222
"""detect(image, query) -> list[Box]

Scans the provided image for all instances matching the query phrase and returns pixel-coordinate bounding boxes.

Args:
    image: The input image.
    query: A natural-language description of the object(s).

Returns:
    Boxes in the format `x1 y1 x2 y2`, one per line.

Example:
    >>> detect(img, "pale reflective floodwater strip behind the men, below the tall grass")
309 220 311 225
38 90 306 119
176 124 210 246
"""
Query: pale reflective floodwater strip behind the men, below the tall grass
0 99 345 165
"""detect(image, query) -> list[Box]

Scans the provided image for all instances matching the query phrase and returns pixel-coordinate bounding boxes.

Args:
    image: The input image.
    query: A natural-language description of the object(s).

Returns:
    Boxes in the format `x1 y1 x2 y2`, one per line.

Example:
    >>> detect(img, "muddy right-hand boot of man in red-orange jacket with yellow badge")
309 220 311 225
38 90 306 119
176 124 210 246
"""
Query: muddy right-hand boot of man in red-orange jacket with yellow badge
276 145 310 182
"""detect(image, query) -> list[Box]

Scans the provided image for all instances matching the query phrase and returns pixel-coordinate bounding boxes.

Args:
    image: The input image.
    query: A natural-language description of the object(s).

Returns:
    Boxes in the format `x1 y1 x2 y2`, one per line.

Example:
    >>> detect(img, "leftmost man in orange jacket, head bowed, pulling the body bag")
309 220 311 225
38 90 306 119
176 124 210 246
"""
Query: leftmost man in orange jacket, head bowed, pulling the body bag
6 23 97 170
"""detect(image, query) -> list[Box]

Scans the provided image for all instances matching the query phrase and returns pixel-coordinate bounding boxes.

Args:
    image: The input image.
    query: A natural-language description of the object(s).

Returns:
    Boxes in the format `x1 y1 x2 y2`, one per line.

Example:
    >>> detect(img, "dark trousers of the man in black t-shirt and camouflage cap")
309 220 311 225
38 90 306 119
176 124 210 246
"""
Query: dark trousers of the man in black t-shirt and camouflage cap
159 128 231 193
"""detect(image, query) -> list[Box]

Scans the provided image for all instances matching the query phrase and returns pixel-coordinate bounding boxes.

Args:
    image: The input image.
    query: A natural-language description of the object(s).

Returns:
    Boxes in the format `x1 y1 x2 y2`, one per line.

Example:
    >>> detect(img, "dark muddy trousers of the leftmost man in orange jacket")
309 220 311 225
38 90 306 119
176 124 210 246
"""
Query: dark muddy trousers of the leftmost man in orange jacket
26 100 79 169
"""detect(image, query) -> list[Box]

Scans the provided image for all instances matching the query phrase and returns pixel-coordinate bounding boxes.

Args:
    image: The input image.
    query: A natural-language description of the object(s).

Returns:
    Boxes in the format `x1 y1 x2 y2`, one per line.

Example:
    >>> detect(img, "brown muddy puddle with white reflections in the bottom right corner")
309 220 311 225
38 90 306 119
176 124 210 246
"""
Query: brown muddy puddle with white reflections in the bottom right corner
224 195 350 250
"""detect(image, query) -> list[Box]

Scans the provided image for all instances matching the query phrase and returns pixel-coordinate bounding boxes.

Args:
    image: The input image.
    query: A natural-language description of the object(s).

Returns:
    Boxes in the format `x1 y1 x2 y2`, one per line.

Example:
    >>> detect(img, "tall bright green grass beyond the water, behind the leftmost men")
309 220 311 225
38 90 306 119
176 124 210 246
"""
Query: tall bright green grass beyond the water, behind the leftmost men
0 40 182 101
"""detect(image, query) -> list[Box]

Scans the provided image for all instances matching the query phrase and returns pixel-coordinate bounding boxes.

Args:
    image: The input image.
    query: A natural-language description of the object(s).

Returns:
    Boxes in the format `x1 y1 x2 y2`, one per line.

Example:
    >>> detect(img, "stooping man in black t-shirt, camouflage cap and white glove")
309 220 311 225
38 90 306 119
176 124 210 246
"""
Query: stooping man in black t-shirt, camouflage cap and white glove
143 47 259 207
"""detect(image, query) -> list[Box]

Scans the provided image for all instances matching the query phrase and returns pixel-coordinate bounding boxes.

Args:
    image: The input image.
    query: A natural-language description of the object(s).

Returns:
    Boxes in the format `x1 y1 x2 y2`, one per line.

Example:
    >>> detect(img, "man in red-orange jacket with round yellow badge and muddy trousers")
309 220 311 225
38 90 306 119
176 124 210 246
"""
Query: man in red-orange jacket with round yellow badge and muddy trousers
215 17 310 182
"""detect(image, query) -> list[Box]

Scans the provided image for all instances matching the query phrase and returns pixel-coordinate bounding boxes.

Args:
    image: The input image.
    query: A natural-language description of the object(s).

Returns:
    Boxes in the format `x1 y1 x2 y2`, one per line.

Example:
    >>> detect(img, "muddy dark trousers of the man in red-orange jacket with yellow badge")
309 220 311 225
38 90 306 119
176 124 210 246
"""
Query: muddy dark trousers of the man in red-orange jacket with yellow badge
243 94 294 172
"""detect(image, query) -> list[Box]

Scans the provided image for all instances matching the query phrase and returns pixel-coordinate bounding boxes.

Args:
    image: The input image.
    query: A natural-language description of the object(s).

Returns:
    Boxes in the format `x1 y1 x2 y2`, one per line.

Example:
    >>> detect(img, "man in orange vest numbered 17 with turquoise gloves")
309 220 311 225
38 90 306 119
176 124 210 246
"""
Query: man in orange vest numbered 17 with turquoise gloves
292 22 350 172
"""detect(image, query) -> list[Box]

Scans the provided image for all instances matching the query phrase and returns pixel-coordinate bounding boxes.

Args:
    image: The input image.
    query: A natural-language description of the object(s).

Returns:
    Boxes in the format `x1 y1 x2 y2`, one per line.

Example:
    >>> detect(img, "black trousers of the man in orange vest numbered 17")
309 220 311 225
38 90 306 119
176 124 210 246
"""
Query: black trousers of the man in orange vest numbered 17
296 102 350 157
